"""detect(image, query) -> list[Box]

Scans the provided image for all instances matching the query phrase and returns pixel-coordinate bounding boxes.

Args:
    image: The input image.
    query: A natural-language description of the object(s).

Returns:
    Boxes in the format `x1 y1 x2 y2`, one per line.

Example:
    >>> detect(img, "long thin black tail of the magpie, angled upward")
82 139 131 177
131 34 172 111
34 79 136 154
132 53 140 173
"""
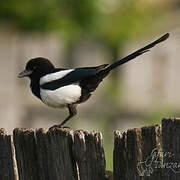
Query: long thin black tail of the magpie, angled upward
104 33 169 72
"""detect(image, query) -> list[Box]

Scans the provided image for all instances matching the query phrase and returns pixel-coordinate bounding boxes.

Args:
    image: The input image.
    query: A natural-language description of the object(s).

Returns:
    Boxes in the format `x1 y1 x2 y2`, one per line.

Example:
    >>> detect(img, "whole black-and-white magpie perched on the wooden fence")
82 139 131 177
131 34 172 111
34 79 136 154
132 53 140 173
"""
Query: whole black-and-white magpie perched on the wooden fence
18 33 169 129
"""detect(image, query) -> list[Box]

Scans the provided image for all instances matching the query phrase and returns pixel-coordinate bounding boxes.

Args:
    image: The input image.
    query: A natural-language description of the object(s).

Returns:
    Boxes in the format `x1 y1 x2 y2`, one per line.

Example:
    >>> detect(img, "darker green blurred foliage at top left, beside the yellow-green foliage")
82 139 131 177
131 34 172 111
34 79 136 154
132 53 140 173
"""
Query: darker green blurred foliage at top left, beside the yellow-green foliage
0 0 98 38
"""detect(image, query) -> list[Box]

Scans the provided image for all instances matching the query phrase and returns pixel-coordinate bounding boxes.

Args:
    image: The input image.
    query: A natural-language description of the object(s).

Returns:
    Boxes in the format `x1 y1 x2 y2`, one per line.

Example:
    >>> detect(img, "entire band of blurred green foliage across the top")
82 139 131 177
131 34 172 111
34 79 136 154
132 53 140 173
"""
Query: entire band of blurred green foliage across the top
0 0 165 44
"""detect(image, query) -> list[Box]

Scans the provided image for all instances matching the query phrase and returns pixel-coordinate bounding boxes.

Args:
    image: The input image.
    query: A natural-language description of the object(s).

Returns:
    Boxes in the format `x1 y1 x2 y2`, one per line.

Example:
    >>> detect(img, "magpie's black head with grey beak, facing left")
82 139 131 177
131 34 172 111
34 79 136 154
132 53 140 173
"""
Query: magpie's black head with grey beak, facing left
18 57 54 78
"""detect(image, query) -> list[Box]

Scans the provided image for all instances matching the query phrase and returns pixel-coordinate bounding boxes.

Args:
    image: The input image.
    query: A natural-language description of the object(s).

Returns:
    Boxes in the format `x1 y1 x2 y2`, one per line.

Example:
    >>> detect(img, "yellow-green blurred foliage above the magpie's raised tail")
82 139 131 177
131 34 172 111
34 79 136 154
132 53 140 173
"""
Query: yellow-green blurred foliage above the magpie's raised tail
98 0 162 50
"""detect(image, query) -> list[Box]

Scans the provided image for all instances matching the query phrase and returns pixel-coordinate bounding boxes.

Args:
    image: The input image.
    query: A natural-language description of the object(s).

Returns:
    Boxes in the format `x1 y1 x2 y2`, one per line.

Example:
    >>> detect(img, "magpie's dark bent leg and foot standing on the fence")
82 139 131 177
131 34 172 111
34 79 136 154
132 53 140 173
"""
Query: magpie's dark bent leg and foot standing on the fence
49 104 77 130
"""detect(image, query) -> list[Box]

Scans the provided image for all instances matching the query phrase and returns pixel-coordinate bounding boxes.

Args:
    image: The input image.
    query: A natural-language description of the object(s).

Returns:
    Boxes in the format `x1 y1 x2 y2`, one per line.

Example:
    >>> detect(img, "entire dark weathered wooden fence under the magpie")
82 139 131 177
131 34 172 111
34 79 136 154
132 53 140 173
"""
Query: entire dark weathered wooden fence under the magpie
0 118 180 180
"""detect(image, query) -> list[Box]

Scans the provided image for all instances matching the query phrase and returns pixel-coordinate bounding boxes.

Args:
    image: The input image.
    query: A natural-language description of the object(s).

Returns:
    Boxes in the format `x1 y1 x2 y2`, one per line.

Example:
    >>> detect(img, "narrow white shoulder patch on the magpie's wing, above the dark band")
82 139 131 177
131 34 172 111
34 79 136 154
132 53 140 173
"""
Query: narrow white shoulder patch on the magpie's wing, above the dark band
40 69 74 85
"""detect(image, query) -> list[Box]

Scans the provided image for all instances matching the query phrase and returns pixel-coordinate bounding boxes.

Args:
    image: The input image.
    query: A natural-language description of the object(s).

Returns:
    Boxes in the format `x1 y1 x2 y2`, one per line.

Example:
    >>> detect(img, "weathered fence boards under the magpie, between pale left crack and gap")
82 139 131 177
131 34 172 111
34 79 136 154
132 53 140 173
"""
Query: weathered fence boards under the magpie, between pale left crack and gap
11 128 106 180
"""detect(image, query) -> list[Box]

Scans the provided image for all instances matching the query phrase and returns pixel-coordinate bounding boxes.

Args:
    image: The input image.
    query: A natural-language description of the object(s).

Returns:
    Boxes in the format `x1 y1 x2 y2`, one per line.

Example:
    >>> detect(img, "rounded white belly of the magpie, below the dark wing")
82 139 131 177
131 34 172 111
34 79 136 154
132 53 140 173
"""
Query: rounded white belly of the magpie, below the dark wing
40 84 81 108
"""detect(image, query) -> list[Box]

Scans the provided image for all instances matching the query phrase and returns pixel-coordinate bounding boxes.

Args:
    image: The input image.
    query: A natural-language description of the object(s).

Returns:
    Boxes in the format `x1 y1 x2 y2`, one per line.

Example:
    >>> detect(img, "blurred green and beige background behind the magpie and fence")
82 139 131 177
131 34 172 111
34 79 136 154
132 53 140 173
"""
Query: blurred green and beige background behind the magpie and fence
0 0 180 169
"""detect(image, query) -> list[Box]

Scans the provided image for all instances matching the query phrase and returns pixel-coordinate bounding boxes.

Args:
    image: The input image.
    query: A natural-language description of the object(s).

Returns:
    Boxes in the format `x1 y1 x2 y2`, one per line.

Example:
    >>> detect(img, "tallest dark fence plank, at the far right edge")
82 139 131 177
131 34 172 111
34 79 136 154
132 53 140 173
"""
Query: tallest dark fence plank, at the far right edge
162 118 180 180
